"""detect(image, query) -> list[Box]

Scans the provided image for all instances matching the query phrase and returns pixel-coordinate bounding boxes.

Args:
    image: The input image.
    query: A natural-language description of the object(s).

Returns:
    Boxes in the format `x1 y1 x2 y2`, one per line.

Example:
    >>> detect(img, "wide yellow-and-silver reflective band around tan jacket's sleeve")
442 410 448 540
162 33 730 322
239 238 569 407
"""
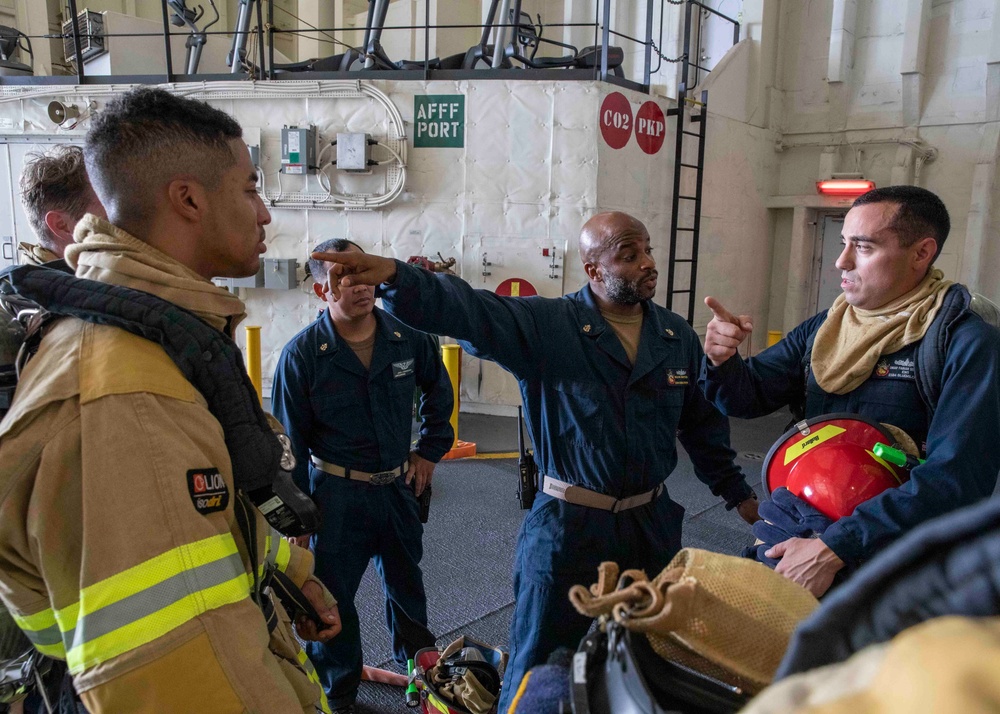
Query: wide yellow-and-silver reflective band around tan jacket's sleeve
17 533 250 674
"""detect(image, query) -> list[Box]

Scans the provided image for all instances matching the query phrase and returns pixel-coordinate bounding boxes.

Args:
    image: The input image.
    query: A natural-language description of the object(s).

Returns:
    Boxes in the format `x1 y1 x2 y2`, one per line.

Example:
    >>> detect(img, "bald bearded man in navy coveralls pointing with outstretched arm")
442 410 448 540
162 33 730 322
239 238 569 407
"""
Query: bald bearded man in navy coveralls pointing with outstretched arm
312 213 757 712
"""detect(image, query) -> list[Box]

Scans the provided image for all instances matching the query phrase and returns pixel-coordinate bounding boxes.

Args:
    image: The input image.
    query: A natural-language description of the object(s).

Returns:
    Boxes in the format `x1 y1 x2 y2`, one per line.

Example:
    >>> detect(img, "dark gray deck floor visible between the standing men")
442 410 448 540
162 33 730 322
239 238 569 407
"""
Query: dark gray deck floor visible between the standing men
348 412 789 714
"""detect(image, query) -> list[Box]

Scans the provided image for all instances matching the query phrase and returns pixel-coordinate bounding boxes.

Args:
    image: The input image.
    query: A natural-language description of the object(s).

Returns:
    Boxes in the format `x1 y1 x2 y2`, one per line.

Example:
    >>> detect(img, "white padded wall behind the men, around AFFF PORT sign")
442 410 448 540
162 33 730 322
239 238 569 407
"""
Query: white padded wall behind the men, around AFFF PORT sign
0 81 672 410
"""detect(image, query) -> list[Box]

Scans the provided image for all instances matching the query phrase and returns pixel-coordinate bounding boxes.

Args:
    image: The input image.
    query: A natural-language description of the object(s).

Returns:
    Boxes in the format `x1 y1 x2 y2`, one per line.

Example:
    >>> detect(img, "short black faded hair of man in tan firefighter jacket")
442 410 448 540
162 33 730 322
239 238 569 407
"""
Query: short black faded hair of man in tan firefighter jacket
84 87 243 238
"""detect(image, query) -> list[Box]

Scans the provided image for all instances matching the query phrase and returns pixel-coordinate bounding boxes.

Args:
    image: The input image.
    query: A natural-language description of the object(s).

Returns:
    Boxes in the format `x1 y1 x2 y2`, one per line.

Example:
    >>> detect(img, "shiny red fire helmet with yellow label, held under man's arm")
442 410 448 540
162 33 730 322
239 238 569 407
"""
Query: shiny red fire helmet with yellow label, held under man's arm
762 414 910 520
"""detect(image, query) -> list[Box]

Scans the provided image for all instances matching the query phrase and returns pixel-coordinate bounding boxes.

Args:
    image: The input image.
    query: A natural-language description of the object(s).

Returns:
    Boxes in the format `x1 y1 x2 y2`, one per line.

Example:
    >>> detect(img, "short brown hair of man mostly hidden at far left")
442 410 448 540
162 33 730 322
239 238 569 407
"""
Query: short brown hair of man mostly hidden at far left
20 144 94 249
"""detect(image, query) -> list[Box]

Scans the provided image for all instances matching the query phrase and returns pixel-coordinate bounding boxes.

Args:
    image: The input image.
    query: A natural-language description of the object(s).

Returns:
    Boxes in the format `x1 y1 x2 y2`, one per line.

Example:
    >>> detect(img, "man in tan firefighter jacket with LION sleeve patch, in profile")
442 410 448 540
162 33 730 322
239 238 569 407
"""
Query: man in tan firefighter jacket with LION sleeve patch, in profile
0 88 340 714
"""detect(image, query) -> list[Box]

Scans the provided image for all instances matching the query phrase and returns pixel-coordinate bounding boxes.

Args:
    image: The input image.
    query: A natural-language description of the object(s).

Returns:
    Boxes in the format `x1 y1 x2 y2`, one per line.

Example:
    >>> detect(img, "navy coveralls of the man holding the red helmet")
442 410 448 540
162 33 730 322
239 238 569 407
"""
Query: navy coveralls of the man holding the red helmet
702 288 1000 565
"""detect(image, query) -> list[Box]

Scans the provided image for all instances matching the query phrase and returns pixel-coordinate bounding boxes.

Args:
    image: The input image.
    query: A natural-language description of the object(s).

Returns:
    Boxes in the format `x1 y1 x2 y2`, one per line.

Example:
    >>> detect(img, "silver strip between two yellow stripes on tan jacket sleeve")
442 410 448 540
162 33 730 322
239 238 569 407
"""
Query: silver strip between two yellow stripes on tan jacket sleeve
63 553 249 651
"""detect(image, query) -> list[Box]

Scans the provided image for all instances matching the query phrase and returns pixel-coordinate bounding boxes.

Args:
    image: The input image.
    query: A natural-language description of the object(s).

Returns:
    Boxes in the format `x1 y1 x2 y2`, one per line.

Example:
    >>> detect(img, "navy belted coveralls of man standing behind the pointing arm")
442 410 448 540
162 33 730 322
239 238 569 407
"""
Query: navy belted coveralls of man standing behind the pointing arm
271 308 454 708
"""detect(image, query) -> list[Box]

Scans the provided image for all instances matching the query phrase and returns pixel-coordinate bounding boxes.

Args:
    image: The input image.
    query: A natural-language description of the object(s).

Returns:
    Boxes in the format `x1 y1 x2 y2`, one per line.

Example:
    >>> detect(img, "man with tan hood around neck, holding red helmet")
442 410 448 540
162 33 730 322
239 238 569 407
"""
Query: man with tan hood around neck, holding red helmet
700 186 1000 596
